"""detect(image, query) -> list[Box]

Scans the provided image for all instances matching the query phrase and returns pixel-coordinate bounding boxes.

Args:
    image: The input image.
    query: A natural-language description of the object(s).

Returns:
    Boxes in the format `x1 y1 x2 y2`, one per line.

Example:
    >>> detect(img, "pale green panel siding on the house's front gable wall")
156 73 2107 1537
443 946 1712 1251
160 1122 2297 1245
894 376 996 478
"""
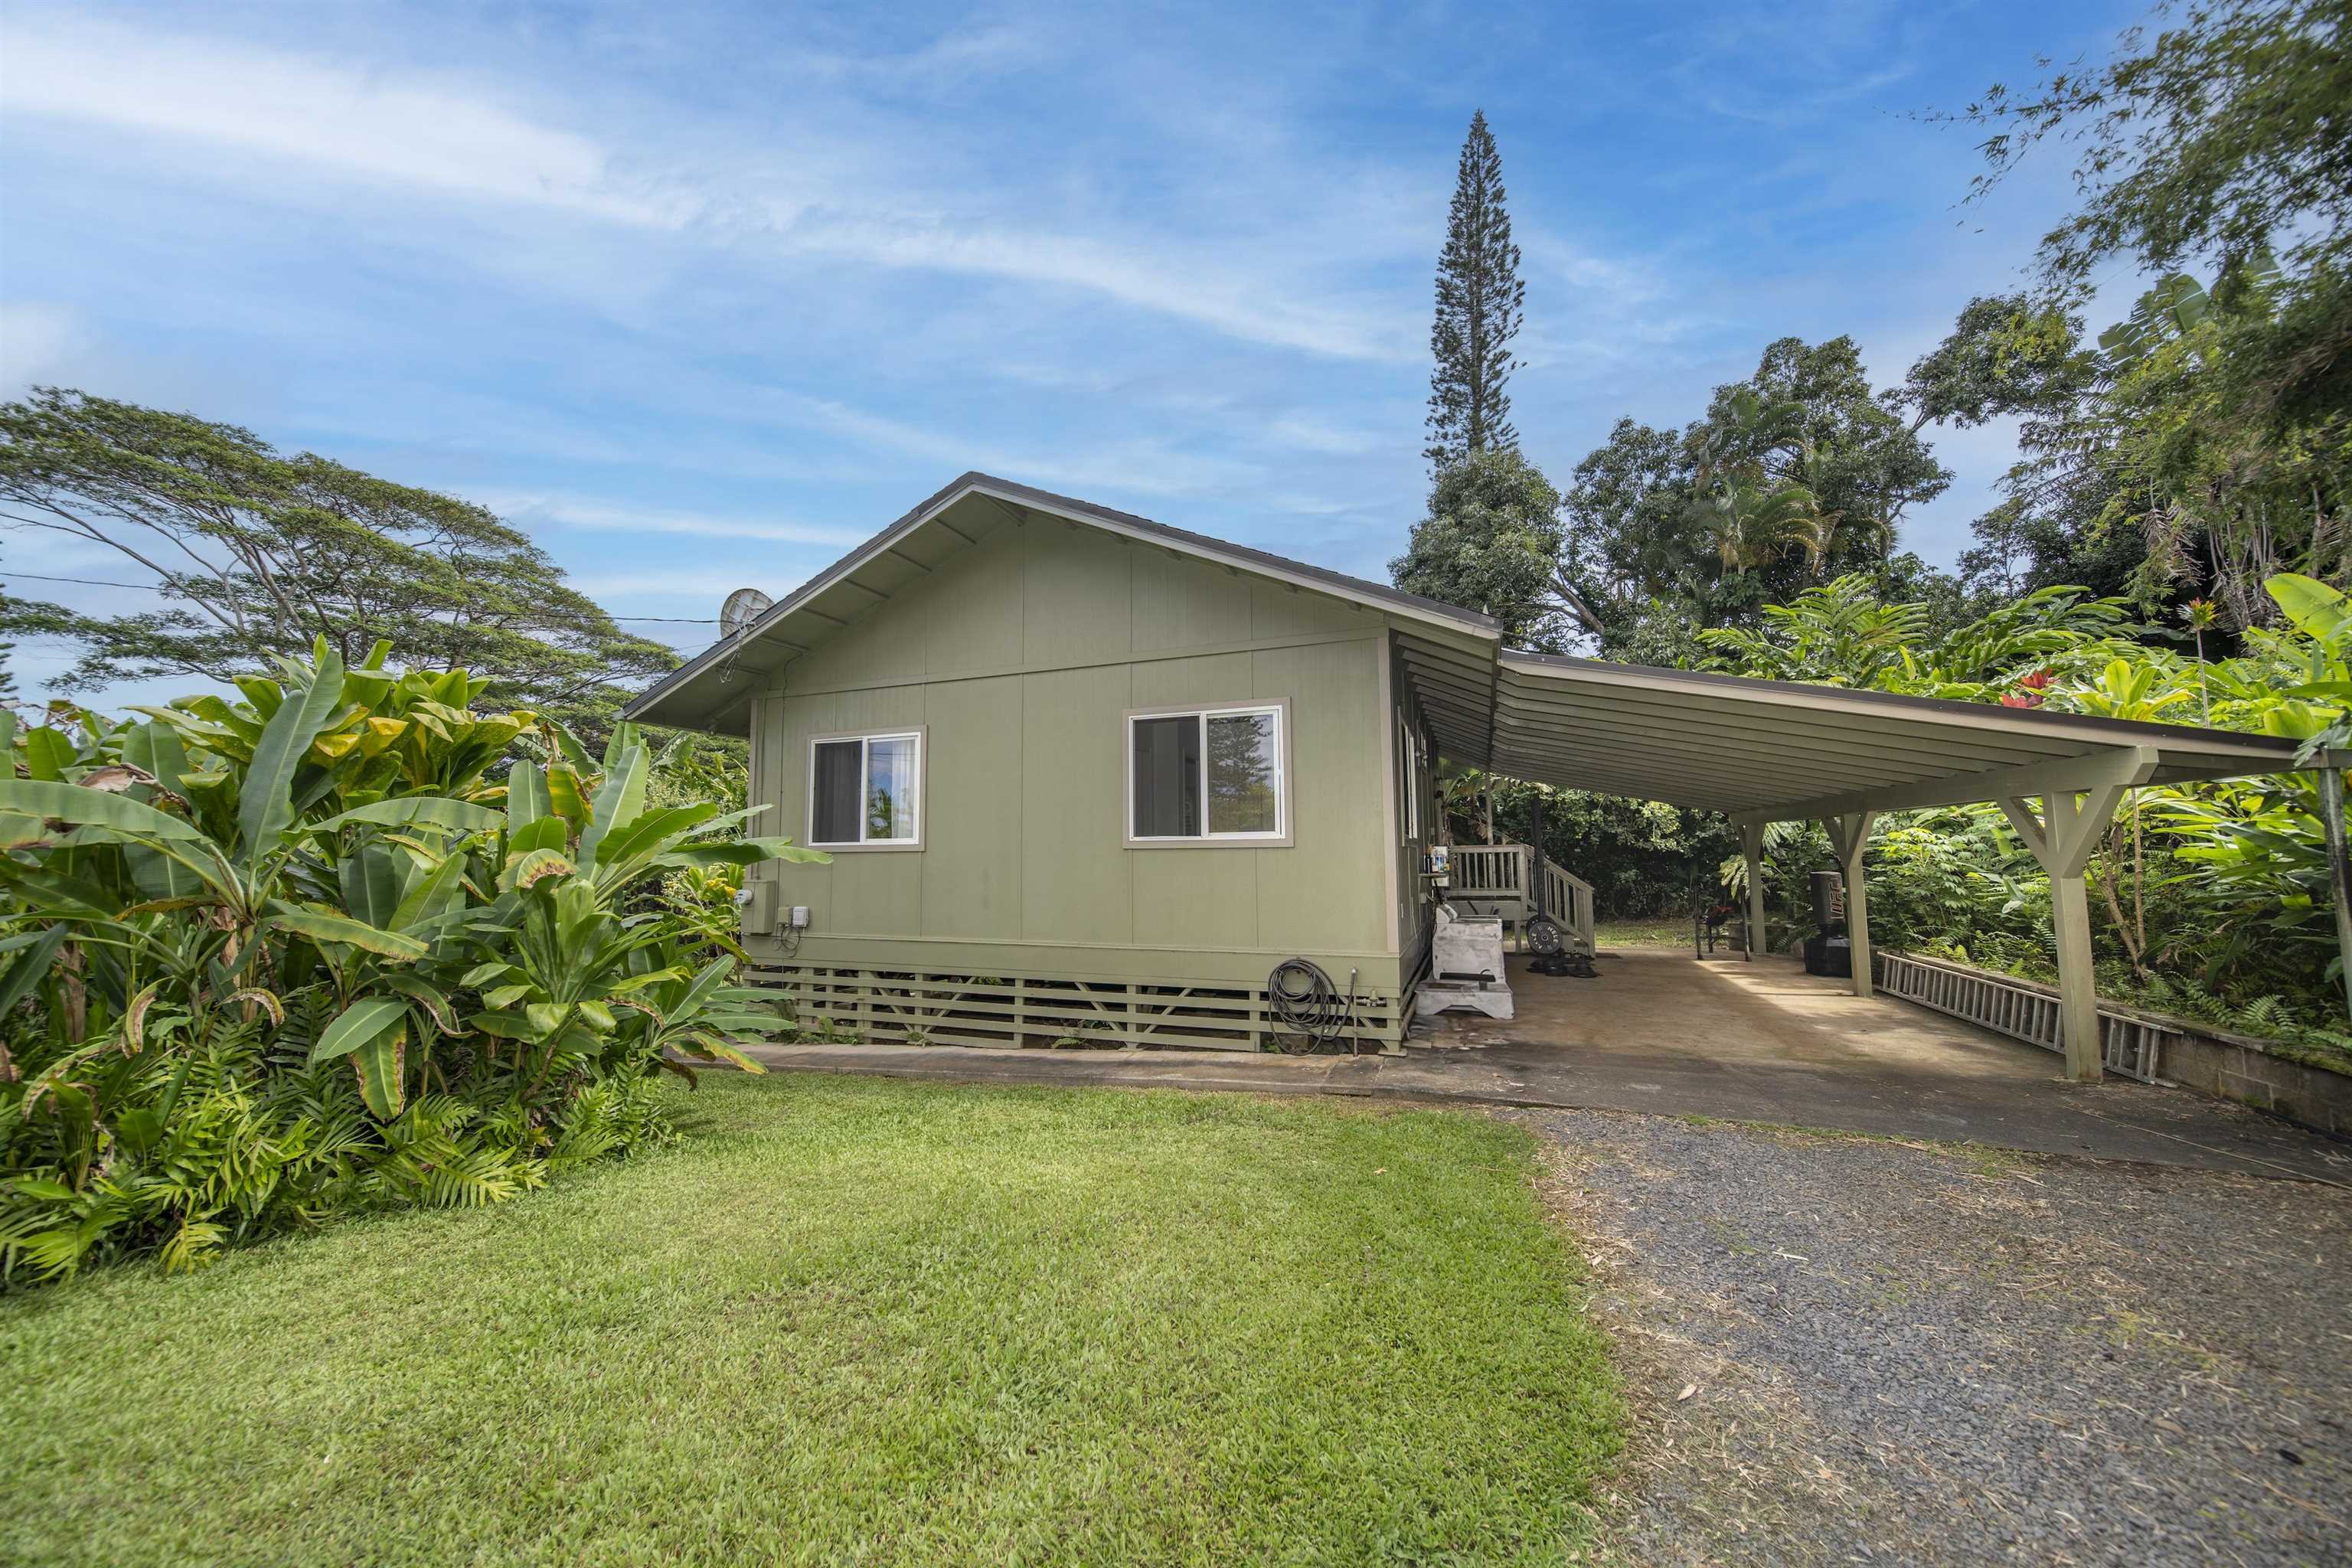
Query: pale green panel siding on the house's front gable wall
753 522 1397 988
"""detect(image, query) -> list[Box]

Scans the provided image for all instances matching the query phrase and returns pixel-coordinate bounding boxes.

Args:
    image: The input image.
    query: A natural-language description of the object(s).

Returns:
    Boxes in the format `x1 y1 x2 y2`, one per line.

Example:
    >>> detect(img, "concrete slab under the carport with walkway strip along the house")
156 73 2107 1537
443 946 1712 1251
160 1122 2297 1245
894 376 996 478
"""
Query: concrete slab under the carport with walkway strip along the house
753 947 2352 1185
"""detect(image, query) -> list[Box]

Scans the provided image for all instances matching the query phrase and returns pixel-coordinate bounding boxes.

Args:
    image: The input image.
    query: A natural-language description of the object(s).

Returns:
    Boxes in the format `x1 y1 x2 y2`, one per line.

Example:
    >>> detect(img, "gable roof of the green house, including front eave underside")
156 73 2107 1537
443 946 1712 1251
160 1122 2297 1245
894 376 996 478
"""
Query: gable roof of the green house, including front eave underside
623 472 1503 729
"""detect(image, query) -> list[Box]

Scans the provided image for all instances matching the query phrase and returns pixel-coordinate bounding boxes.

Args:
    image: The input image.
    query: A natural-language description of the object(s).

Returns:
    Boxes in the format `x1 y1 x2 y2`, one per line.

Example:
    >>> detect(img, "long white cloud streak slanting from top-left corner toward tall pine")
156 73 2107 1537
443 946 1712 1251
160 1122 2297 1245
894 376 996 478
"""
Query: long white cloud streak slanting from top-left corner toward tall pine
0 19 1416 360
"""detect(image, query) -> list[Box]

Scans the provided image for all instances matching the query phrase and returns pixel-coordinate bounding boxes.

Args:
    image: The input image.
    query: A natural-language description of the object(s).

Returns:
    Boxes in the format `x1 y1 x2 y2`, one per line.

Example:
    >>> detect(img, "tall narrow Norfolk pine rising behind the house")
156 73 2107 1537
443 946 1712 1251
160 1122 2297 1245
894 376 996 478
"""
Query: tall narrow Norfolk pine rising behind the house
1423 110 1527 472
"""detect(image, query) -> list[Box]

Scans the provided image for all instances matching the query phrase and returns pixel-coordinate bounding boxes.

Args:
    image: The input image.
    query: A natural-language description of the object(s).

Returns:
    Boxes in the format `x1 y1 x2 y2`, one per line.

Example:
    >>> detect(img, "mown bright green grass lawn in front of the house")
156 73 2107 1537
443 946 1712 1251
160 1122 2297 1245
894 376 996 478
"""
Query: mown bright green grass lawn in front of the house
0 1074 1621 1566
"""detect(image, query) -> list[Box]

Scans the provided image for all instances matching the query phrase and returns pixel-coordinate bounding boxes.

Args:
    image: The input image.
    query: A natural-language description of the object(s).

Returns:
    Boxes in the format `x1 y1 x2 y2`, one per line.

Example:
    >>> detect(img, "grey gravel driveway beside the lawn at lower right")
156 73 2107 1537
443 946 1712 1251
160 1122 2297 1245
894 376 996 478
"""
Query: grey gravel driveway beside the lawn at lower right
1510 1112 2352 1566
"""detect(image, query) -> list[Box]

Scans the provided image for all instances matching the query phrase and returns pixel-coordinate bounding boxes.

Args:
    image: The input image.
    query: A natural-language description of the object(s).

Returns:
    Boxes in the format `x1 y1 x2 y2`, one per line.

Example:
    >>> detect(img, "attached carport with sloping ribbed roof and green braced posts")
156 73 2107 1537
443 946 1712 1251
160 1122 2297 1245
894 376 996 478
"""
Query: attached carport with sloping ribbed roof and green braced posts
1402 637 2352 1081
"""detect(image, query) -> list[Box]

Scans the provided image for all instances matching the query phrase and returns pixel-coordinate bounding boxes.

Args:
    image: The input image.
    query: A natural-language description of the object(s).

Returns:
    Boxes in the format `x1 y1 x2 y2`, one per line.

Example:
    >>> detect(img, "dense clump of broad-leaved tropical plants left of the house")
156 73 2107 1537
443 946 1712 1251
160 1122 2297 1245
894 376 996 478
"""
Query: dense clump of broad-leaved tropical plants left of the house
0 642 809 1281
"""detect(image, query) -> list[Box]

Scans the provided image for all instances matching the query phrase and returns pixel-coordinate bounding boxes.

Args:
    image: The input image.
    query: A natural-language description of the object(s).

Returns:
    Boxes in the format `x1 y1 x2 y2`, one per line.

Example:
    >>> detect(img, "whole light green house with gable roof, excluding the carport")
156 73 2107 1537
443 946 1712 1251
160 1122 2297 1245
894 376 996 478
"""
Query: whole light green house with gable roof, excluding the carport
630 472 1498 1048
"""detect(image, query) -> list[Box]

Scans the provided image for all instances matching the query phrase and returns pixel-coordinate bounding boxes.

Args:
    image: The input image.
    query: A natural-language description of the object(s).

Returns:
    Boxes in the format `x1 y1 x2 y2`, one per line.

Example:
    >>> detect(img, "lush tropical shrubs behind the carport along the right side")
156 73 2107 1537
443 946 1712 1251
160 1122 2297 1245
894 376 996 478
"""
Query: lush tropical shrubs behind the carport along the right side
1703 573 2352 1067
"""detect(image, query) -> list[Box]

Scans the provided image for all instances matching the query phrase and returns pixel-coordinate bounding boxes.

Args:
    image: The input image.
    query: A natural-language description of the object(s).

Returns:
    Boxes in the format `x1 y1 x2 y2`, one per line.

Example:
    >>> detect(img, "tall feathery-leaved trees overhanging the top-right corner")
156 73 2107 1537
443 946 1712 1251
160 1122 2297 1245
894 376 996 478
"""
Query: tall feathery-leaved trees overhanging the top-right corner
1915 0 2352 630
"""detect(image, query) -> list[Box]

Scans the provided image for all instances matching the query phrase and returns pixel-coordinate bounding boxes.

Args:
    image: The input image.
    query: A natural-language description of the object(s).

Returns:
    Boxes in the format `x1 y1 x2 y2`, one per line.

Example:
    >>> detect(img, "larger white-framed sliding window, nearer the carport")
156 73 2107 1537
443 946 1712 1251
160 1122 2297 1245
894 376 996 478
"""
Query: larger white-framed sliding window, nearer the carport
1126 703 1292 848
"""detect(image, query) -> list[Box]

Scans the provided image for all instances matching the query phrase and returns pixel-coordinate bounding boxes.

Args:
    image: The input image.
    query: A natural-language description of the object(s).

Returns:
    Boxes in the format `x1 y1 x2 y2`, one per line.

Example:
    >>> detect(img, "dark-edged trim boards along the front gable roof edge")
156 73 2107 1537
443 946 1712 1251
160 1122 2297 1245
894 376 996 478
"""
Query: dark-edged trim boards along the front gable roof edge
621 470 1503 720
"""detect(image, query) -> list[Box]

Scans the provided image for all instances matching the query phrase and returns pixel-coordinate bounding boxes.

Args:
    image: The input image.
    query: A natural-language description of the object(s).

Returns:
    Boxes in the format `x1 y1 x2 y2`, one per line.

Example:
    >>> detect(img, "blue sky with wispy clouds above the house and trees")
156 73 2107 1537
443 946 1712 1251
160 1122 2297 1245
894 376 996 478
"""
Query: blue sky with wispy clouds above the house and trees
0 0 2141 701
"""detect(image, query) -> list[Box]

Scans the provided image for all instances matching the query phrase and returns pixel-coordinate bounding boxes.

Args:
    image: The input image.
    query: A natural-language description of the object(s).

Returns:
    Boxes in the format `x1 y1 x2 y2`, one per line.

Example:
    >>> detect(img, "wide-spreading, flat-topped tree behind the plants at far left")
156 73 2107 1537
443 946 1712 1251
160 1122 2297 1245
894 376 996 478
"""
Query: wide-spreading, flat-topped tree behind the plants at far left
0 388 678 712
